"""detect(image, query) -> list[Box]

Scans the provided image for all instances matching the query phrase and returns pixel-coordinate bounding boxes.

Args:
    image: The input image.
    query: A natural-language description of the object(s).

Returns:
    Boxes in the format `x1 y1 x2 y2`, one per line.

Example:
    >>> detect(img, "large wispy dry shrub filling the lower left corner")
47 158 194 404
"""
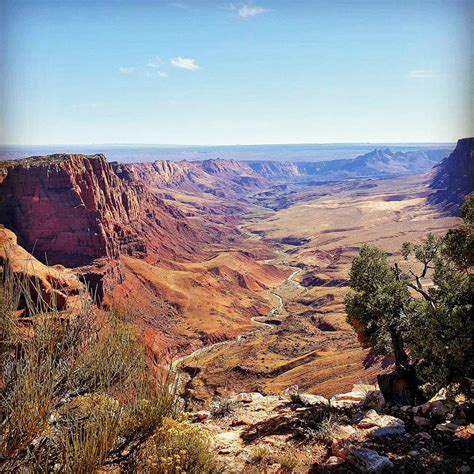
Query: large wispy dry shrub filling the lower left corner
0 264 190 473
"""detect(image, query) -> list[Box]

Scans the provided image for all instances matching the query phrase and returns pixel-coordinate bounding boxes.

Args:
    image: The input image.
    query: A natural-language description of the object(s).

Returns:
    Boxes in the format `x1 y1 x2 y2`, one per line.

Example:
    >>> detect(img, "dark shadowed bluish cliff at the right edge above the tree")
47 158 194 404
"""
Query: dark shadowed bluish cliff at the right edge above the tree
429 138 474 211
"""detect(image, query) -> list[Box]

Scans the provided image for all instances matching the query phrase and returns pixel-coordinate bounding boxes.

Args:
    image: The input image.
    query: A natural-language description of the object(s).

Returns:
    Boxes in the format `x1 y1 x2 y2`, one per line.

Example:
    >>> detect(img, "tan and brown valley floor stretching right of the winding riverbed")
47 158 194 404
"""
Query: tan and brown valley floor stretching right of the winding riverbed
174 172 458 405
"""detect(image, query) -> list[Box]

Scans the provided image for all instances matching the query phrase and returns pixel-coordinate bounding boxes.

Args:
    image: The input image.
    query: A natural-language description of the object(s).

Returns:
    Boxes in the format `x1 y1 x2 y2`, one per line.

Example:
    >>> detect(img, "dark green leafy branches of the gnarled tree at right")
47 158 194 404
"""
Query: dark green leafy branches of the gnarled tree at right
345 195 474 391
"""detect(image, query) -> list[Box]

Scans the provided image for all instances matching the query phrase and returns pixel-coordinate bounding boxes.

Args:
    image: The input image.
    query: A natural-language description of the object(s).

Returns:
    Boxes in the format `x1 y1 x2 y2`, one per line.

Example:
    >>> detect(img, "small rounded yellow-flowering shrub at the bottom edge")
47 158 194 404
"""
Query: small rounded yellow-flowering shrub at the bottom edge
147 418 217 474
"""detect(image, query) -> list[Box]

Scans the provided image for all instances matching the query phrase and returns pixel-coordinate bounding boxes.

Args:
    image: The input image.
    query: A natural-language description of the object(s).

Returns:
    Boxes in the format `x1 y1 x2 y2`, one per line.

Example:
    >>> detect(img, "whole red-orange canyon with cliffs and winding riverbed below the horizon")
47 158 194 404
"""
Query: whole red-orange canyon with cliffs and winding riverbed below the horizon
0 139 473 406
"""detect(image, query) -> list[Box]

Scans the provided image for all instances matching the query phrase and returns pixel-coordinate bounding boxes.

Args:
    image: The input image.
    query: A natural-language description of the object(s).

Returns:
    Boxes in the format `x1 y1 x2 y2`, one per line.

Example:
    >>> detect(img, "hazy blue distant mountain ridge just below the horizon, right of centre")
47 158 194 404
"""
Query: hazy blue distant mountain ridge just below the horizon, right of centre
248 148 449 181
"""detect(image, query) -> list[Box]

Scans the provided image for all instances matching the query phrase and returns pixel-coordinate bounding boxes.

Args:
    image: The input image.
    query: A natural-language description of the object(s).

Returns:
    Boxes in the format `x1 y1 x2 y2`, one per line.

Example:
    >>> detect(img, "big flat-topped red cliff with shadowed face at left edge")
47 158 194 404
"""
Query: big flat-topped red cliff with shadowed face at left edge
0 155 144 266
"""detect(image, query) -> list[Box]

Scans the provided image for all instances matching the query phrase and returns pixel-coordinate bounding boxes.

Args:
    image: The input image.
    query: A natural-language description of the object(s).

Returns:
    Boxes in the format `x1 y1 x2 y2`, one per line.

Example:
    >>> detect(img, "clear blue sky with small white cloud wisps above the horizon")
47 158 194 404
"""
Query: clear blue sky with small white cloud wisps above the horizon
0 0 474 145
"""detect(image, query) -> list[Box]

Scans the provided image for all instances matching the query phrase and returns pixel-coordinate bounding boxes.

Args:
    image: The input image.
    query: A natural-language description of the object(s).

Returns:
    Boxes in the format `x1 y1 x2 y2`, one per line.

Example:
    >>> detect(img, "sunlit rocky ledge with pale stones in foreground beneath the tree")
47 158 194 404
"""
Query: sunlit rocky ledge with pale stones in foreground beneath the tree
190 385 474 473
